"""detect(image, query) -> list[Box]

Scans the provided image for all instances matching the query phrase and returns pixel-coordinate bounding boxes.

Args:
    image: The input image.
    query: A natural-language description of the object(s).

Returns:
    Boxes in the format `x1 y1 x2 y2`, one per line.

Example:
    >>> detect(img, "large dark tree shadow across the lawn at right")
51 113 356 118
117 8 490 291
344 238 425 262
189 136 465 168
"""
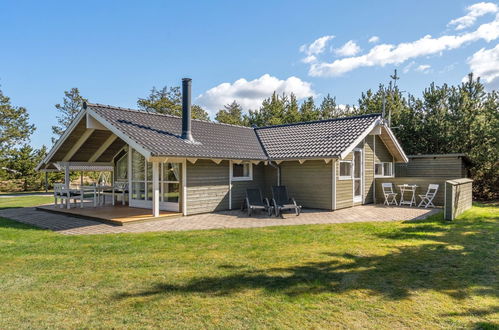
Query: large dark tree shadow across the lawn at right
116 206 499 300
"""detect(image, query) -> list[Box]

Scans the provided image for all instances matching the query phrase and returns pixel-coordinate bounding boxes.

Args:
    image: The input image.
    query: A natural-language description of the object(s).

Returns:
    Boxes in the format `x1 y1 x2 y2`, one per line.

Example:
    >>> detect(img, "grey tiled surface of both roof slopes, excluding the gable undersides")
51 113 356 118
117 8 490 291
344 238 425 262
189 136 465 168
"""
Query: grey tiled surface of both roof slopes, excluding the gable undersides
88 104 381 160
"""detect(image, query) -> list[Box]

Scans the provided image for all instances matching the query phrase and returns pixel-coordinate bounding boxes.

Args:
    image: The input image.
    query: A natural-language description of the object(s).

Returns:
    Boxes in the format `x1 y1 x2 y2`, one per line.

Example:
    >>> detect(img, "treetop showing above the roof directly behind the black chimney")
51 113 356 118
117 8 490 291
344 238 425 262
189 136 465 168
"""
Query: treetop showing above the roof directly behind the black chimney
137 86 210 120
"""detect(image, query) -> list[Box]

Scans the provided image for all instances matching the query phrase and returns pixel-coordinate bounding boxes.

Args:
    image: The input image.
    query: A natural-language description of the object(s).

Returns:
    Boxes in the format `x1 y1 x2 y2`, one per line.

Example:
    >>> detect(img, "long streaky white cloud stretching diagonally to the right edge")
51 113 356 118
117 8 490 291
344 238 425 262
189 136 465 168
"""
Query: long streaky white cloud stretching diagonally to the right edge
309 11 499 77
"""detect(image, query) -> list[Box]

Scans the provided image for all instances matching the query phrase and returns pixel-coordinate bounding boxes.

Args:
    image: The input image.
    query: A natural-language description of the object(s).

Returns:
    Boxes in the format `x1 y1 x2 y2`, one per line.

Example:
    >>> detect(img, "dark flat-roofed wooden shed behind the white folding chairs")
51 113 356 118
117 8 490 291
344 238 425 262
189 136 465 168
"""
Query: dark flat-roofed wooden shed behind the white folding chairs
395 154 470 178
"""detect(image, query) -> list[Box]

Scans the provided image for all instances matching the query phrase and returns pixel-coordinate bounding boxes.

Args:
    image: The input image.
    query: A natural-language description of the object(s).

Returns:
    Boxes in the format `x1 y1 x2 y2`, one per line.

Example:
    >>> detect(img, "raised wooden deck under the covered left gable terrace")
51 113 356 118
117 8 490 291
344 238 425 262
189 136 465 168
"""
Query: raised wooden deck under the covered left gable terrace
37 204 182 226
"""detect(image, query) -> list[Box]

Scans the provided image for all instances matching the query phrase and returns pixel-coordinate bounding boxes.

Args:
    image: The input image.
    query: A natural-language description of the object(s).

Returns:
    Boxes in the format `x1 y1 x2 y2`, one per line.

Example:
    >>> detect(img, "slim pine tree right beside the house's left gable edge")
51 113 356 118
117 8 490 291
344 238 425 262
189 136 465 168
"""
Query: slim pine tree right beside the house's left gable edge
52 87 87 143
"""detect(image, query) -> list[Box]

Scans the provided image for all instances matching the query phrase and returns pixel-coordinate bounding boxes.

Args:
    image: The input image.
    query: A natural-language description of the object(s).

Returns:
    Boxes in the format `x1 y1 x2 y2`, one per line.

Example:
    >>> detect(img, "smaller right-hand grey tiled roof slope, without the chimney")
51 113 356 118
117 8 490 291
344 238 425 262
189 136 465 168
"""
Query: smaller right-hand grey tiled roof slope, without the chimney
255 114 381 159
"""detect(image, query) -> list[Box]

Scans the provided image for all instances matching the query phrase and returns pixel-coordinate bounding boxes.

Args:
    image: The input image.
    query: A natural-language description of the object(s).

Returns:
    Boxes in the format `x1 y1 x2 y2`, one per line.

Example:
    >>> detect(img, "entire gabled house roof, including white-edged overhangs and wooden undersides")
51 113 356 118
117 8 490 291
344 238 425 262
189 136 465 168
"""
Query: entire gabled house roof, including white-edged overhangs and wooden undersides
37 104 407 169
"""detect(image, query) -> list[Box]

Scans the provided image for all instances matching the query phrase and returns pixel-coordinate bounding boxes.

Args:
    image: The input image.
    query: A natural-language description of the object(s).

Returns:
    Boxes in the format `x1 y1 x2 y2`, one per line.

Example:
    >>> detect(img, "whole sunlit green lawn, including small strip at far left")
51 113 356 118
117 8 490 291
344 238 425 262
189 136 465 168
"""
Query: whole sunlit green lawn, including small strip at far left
0 197 499 329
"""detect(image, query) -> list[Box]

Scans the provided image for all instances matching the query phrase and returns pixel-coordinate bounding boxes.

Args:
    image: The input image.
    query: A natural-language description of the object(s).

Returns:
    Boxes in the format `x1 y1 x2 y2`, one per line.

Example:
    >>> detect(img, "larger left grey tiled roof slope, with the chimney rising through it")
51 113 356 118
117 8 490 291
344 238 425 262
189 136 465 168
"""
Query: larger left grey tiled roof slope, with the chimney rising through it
88 104 267 160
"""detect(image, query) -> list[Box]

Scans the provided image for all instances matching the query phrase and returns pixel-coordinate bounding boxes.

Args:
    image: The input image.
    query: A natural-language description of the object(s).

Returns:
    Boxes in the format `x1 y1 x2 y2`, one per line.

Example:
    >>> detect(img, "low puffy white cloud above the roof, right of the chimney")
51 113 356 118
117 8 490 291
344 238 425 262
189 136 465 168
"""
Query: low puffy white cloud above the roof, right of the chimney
196 74 316 114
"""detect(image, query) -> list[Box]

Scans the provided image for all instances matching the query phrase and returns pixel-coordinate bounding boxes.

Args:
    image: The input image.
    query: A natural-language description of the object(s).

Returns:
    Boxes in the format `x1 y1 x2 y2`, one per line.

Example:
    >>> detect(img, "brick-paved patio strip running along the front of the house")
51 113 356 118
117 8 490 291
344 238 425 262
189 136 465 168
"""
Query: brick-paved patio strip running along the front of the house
0 205 441 235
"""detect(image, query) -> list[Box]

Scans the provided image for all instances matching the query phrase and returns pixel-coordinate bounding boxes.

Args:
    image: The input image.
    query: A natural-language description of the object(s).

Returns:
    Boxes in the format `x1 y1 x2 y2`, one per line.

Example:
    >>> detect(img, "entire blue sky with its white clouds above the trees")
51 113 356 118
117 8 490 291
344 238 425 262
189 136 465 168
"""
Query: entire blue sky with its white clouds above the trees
0 0 499 147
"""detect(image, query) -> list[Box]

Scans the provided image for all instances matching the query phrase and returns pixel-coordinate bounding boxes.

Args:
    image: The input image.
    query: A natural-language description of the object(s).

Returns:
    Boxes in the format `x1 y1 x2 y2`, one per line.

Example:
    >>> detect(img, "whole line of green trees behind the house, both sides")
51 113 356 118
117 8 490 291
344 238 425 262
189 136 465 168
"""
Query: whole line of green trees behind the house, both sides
0 74 499 199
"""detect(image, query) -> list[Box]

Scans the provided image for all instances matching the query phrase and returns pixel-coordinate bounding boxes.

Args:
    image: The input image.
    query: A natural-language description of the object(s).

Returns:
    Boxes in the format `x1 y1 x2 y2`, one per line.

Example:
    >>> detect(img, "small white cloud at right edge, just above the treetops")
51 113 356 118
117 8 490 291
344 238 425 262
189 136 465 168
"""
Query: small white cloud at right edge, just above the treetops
463 44 499 88
